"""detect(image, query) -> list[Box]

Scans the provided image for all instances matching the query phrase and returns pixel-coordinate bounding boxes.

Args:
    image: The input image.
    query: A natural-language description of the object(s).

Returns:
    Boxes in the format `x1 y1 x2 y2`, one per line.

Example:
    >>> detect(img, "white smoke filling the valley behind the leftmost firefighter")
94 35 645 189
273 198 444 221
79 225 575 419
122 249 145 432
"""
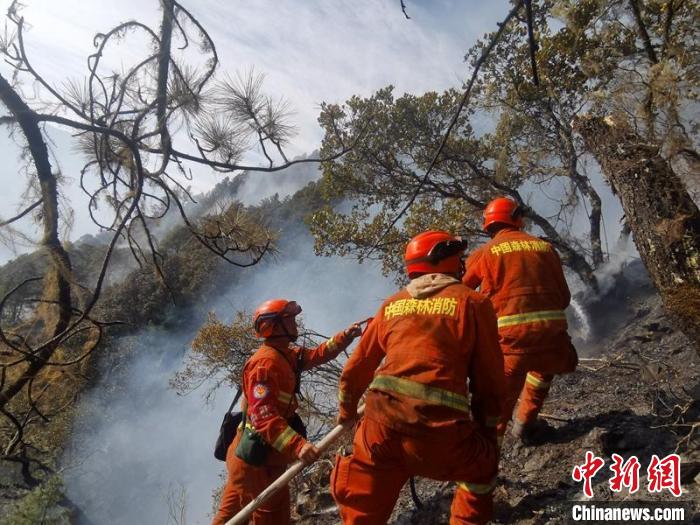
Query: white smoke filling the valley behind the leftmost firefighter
64 234 394 525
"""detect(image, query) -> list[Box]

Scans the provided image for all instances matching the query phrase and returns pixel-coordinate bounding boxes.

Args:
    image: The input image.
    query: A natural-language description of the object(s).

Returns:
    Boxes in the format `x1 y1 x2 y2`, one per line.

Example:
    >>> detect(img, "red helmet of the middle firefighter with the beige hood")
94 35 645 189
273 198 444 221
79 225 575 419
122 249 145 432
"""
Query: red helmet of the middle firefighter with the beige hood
404 230 467 279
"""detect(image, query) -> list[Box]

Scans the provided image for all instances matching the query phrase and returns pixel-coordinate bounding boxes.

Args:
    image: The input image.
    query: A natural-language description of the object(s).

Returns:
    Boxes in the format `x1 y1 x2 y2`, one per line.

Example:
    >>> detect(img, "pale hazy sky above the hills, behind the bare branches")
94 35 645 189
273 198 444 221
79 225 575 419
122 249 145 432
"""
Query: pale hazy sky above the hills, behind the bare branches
0 0 509 262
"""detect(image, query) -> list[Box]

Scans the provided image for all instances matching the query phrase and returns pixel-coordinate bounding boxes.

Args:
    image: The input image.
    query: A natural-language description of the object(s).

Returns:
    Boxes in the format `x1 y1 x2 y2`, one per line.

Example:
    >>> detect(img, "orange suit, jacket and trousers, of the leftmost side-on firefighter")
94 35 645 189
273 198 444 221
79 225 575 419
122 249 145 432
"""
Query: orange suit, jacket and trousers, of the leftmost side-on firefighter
212 332 352 525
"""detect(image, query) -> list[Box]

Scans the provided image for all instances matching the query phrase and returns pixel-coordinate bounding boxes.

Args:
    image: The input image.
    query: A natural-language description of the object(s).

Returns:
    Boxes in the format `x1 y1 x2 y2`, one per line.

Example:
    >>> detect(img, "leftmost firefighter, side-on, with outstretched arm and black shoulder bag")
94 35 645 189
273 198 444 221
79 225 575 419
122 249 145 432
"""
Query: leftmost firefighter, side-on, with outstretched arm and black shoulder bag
213 299 361 525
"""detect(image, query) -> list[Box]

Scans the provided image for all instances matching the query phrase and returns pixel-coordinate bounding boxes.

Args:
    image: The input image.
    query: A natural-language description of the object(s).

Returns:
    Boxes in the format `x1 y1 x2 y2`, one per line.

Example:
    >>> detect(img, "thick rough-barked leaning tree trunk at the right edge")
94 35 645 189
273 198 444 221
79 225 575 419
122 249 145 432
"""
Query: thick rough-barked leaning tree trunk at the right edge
574 117 700 352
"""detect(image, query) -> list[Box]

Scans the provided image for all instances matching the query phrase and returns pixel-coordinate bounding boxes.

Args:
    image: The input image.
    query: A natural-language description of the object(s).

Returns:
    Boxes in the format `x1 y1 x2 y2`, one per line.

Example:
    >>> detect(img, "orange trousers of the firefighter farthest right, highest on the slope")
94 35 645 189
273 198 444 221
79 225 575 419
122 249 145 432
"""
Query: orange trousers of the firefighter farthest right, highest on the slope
497 346 578 440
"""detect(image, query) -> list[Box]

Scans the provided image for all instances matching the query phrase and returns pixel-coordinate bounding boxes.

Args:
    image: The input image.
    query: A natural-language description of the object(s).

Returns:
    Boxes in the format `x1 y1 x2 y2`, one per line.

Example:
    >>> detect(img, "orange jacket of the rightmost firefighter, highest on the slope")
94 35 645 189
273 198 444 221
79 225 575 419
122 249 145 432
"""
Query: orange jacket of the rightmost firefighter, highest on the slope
463 228 571 354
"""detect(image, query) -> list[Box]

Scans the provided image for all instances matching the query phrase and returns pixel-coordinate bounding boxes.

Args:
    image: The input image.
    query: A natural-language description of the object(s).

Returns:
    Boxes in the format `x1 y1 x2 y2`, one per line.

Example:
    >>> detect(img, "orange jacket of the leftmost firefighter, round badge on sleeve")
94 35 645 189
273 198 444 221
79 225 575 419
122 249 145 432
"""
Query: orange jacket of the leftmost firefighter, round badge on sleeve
243 332 352 465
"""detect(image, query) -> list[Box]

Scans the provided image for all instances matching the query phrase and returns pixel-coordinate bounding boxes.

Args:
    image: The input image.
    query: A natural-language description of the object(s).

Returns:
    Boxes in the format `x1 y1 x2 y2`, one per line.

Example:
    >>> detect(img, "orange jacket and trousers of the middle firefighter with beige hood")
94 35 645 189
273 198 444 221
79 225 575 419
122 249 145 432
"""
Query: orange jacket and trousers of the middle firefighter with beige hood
331 274 503 525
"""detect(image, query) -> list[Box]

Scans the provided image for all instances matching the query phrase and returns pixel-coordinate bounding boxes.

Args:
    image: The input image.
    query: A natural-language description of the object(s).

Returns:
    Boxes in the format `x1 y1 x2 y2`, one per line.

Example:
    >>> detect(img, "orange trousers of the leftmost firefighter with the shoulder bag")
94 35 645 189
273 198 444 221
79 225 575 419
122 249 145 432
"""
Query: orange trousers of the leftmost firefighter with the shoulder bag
212 431 290 525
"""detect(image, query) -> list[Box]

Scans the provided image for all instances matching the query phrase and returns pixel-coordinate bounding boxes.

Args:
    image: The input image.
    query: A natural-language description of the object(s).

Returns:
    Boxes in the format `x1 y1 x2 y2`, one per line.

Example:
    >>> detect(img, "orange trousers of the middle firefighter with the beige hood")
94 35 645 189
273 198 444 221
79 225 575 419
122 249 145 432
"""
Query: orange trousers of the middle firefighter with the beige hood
331 417 498 525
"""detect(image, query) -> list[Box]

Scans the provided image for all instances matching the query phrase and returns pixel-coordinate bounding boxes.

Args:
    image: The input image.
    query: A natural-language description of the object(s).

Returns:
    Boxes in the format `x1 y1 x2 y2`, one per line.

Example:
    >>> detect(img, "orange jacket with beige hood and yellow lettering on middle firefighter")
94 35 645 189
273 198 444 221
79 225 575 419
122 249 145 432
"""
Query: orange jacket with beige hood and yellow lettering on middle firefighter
338 274 503 436
